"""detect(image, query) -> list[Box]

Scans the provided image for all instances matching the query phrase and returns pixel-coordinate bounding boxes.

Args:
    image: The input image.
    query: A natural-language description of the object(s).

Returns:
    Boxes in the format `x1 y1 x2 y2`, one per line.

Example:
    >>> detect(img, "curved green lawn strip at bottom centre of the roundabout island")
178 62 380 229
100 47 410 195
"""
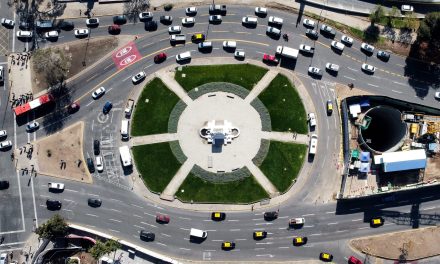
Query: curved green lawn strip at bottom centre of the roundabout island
176 174 269 203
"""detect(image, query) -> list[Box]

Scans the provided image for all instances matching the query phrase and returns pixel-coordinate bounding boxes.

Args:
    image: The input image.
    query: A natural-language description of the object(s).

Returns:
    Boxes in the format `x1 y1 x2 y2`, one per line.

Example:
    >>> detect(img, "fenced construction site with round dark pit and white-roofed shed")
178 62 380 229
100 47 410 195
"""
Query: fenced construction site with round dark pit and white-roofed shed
338 96 440 199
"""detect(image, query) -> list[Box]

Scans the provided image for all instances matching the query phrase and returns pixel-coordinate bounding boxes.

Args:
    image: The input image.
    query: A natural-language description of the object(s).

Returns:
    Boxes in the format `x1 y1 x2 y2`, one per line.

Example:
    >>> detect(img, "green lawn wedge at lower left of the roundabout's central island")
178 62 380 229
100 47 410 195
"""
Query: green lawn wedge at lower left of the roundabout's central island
133 142 181 192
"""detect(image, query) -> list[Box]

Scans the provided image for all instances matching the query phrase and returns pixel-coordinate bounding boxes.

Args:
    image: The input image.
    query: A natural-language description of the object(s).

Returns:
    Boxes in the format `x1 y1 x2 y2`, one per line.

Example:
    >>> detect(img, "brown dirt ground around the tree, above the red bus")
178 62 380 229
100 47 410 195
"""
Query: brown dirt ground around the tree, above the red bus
31 36 123 94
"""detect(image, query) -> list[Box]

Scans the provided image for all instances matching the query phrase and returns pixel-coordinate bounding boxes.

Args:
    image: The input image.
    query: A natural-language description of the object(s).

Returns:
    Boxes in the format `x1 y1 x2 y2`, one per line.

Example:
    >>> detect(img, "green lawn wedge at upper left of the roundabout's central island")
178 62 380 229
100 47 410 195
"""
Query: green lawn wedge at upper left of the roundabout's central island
131 78 179 136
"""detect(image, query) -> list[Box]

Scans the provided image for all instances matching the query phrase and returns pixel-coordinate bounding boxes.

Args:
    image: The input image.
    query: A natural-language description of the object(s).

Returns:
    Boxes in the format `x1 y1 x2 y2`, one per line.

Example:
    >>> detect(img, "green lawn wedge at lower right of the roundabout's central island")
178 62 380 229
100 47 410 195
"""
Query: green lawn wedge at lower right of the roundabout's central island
260 141 307 193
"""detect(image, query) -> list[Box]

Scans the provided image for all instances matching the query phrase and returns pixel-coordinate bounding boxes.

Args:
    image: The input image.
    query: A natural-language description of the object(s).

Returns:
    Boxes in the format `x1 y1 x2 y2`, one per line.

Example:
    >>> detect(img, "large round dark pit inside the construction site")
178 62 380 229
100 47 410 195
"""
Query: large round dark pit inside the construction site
359 106 408 153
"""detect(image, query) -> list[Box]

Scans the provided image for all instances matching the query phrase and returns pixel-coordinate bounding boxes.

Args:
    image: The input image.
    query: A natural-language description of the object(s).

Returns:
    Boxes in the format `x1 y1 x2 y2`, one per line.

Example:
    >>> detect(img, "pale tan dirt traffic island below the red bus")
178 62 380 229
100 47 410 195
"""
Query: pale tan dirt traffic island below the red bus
35 122 93 183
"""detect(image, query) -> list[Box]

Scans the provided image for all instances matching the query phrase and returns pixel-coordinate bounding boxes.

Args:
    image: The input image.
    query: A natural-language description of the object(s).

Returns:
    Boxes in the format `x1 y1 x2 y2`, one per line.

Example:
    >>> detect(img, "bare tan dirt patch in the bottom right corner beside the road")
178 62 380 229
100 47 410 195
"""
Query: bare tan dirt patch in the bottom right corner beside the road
350 227 440 261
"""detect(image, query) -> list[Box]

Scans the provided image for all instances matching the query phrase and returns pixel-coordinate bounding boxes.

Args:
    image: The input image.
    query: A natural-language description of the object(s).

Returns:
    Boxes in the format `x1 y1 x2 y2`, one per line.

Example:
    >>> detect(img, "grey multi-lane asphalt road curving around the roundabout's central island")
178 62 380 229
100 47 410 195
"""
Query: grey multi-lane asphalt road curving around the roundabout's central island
0 6 439 263
